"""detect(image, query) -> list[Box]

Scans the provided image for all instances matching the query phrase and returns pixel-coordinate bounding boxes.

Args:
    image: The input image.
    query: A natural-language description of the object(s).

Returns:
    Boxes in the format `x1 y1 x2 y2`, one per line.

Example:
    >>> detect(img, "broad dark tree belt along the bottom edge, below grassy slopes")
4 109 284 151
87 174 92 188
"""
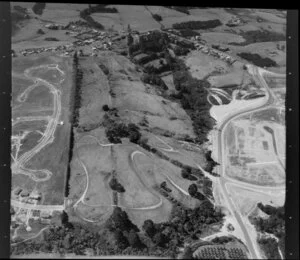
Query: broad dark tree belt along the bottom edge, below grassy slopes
12 201 223 257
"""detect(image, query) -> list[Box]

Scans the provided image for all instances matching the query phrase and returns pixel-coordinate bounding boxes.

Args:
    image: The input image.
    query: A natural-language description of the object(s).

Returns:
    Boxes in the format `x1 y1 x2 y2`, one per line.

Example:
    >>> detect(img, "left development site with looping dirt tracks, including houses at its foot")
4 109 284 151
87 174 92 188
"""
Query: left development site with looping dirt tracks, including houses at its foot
11 57 72 244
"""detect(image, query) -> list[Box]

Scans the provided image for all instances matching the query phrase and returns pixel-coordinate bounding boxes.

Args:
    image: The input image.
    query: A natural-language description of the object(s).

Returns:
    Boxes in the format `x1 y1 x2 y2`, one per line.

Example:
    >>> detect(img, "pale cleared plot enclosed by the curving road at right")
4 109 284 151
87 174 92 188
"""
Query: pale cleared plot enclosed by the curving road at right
225 110 285 186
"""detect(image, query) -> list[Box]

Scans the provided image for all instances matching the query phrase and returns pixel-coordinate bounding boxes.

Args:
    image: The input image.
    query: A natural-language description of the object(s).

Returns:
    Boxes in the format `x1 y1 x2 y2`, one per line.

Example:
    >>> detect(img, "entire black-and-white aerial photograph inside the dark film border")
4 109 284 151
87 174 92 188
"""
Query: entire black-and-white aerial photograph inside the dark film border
10 2 287 259
